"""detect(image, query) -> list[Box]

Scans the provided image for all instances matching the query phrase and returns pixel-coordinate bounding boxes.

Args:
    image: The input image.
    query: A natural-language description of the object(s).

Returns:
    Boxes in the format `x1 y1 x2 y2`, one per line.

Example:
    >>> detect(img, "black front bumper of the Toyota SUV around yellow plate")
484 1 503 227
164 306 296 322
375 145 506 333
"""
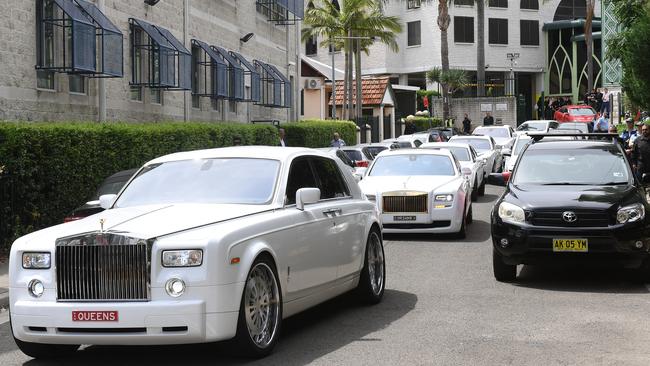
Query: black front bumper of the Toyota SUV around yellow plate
492 219 650 268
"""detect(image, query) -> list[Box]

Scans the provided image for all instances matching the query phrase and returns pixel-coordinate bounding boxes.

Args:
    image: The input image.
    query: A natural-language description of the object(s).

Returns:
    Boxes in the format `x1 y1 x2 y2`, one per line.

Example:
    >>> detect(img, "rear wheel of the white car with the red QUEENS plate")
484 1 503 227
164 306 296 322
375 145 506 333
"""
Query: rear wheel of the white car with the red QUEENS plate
357 229 386 305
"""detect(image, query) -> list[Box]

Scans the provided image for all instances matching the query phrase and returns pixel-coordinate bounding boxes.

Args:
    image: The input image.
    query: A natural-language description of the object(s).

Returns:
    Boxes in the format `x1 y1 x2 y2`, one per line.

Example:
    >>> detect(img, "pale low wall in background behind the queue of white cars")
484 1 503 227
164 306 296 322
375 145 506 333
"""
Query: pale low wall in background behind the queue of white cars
432 97 517 129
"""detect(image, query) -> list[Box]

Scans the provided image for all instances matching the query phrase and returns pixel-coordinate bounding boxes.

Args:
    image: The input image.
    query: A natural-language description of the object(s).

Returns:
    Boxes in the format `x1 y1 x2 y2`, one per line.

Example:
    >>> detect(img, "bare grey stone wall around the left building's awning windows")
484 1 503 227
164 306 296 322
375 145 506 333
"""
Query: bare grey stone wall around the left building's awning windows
0 0 296 122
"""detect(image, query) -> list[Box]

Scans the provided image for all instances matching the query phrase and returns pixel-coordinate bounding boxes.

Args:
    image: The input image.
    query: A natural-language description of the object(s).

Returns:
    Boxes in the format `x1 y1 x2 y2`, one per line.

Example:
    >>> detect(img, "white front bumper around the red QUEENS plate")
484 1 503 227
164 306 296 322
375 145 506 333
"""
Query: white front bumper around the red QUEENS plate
9 283 243 345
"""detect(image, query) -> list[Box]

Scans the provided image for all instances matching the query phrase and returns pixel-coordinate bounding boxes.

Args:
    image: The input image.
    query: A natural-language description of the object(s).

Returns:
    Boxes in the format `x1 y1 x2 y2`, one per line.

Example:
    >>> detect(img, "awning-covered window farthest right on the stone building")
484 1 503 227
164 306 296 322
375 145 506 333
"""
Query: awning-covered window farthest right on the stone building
254 60 291 108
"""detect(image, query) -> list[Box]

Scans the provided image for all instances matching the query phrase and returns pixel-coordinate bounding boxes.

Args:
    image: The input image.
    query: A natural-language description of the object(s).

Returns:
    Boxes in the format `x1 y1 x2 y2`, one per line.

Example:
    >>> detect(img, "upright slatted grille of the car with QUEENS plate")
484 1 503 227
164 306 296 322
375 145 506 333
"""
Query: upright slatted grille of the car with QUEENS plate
56 241 150 301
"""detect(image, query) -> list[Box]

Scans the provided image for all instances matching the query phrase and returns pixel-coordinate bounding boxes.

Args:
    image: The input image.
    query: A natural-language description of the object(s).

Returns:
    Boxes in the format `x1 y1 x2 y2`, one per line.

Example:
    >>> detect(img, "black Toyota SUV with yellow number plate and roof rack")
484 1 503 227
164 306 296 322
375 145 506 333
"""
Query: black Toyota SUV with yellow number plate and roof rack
488 134 650 281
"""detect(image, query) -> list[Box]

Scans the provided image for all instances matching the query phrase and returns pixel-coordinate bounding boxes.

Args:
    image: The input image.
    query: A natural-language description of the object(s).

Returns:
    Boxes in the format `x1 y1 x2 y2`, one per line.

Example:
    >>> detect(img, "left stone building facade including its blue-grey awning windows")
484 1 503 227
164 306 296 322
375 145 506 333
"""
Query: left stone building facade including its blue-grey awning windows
0 0 302 122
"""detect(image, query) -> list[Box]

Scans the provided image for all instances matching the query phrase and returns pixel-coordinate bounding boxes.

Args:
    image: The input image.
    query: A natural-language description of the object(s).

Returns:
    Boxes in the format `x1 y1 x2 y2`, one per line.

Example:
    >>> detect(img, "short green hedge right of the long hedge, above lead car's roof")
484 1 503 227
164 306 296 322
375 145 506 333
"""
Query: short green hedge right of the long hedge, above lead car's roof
280 120 357 148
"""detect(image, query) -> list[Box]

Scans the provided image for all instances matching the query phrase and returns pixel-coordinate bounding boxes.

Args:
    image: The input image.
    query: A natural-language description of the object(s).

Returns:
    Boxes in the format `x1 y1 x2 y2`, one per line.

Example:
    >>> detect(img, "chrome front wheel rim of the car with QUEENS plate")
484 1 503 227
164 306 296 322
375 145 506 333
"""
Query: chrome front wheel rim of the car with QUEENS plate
244 263 280 348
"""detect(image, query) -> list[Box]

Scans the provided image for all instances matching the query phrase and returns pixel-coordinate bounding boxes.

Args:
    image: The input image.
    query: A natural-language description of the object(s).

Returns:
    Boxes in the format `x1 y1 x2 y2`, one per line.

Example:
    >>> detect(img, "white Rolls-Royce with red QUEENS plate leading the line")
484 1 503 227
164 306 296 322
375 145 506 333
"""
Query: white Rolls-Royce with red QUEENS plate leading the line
9 147 385 358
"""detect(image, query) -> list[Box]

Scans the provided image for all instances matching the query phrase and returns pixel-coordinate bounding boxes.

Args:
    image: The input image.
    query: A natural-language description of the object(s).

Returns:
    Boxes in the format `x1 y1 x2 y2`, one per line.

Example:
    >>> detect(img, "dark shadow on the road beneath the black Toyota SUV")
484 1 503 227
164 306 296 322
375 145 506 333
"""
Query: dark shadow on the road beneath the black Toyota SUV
514 264 650 294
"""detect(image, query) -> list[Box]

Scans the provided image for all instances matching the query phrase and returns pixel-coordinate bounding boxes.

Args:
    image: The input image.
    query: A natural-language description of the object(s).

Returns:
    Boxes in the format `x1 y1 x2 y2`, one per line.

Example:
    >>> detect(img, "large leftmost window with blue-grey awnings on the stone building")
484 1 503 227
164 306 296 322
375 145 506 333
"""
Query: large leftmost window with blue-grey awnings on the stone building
36 0 124 77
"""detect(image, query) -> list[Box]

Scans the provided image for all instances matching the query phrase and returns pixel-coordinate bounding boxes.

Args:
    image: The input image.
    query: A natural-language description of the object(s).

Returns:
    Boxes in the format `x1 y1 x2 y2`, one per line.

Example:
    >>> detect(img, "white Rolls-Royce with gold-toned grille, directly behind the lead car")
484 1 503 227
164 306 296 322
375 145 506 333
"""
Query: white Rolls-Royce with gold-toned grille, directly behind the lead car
359 149 472 238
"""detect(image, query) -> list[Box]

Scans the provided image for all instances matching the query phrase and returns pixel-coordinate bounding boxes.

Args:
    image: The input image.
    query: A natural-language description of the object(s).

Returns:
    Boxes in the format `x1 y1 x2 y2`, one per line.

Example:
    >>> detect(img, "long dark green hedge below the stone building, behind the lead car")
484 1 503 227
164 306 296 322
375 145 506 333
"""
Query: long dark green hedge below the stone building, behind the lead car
0 122 278 252
